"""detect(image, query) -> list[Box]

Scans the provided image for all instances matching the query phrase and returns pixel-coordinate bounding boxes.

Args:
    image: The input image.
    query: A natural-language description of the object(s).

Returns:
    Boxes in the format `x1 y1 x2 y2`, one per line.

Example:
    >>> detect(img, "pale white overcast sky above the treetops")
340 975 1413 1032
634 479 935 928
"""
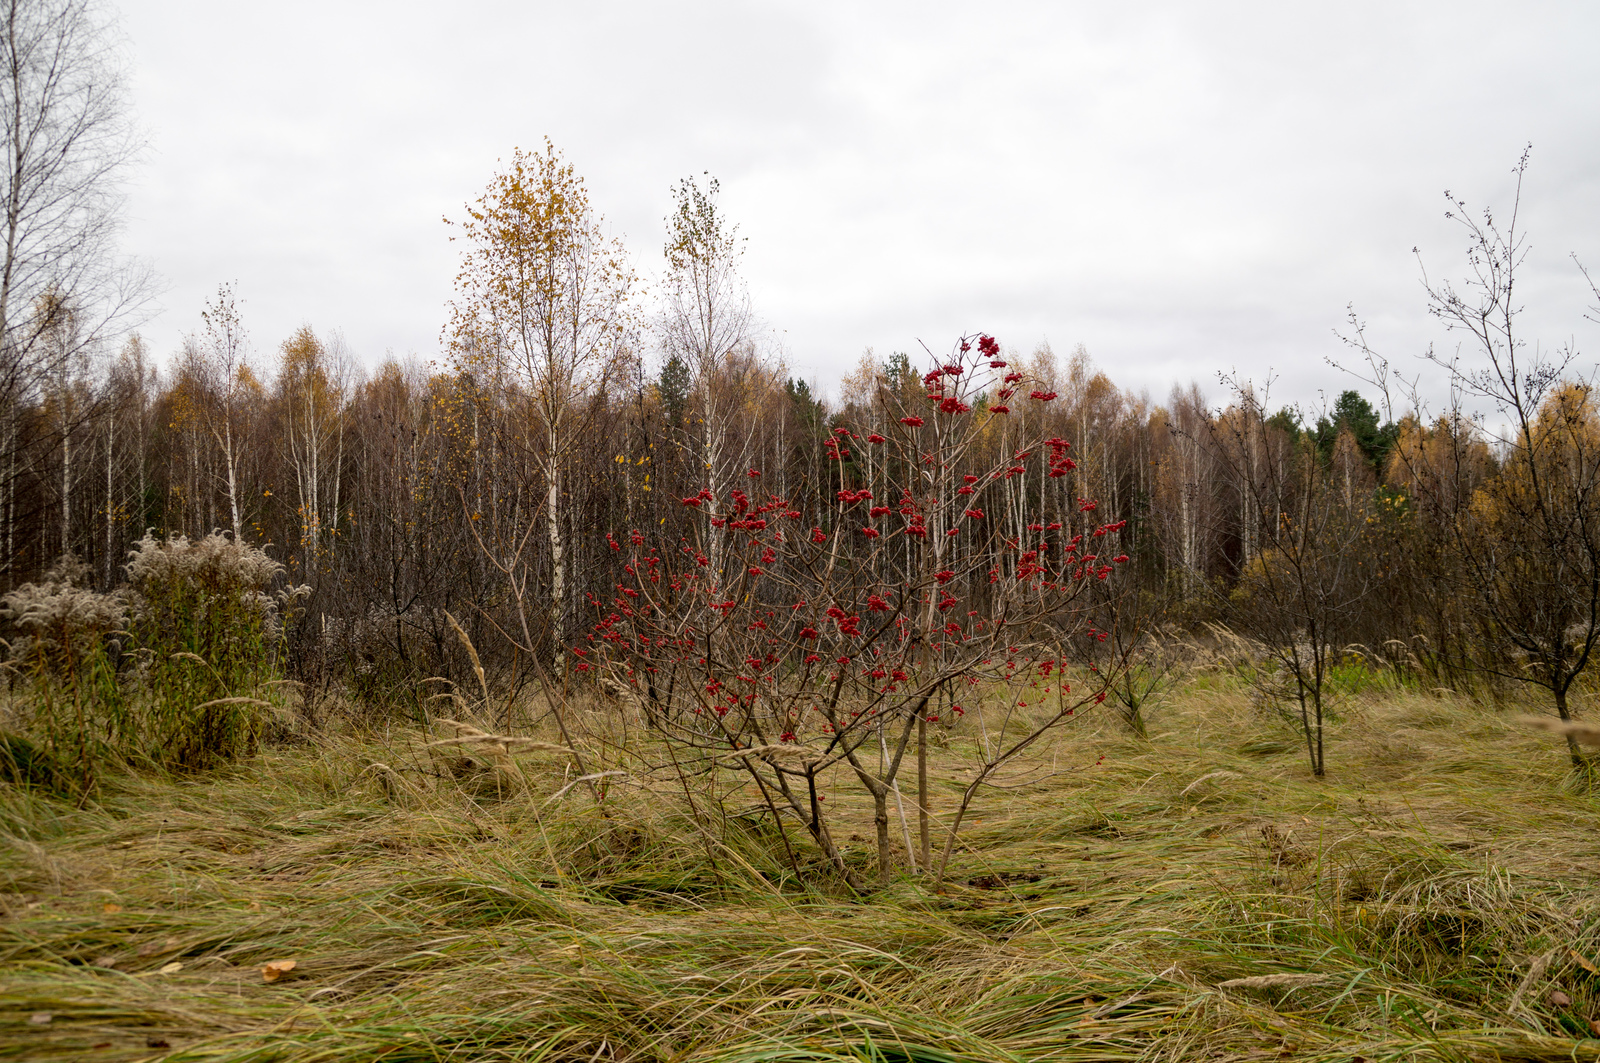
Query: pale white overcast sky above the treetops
120 0 1600 416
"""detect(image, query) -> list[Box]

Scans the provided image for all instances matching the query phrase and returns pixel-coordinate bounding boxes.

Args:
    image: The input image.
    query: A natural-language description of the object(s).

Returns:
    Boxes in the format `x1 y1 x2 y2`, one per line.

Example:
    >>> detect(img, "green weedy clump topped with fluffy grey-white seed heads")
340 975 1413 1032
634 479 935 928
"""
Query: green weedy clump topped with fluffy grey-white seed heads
0 535 309 792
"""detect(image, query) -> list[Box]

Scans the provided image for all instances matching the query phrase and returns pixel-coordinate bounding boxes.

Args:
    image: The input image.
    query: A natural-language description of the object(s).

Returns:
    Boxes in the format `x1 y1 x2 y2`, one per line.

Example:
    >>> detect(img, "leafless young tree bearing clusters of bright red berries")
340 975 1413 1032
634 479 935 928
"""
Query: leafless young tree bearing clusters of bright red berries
574 336 1126 887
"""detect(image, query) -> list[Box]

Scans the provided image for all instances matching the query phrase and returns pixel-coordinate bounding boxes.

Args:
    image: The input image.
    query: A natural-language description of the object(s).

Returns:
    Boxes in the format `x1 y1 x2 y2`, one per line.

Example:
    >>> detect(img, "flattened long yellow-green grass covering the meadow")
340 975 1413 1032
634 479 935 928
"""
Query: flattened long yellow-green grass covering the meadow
0 682 1600 1063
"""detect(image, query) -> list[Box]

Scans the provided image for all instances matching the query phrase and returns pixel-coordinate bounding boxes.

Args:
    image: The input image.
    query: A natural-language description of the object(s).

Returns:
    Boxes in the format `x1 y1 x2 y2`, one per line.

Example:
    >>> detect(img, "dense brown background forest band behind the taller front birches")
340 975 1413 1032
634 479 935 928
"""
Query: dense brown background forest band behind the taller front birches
0 249 1589 717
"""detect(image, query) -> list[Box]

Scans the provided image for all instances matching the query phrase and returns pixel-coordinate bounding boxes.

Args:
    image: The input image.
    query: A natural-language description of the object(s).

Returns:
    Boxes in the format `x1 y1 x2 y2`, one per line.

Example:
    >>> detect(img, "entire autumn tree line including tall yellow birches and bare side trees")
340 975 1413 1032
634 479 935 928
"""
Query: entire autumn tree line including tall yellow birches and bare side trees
0 0 1600 770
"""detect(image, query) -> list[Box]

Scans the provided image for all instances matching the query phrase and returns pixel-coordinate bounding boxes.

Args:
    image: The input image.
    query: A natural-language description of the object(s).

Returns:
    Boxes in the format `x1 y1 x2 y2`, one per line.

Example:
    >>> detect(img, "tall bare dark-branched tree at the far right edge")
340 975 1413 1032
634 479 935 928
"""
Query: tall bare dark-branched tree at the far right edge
1344 150 1600 768
